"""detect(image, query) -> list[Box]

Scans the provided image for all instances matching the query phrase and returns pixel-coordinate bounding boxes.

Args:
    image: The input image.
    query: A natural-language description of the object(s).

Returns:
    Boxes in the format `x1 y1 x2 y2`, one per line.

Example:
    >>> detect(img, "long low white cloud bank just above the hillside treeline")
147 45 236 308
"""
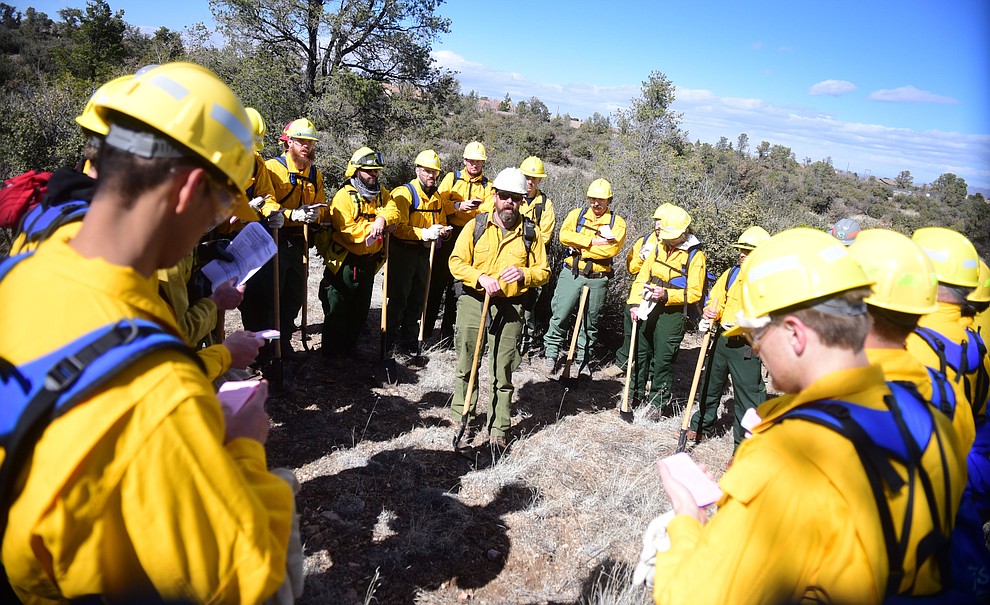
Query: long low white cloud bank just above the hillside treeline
433 51 990 187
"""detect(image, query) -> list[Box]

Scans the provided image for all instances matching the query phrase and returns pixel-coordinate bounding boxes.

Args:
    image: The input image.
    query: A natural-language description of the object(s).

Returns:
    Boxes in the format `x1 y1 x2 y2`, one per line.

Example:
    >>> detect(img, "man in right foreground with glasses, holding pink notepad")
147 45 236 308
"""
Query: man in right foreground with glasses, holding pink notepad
641 228 965 605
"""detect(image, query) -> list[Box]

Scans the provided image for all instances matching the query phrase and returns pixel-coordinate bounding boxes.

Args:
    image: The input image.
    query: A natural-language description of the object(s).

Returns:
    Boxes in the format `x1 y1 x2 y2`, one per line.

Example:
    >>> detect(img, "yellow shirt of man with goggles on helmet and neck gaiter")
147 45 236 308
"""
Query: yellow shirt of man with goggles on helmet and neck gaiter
322 183 399 256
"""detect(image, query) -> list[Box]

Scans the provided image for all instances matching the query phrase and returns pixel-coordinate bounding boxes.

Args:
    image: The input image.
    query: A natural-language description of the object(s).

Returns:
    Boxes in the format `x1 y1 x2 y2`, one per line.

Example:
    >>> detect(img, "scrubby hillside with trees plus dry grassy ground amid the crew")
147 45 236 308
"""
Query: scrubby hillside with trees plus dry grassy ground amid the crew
0 0 990 603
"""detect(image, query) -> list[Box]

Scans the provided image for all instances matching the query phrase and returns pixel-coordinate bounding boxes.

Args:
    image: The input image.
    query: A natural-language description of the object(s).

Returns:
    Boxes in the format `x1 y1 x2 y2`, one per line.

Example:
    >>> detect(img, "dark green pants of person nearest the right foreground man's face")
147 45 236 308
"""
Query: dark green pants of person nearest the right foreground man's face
691 336 767 447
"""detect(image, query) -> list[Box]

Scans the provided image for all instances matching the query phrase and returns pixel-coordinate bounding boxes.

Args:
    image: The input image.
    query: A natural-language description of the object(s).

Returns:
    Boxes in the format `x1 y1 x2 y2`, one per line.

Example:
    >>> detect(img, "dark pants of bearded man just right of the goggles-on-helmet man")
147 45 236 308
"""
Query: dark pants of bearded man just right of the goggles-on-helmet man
385 239 435 348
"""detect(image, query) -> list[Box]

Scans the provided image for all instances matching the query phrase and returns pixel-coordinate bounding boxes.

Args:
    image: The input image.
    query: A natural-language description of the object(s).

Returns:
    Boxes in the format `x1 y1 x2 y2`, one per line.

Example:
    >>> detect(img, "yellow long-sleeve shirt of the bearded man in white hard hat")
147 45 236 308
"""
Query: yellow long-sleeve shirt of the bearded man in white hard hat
449 214 550 298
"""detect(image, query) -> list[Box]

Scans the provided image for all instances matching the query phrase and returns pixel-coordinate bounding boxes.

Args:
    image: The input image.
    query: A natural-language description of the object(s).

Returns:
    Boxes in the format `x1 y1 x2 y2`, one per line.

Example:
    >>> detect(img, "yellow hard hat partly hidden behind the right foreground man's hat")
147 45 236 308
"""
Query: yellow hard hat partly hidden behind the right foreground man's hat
849 229 938 315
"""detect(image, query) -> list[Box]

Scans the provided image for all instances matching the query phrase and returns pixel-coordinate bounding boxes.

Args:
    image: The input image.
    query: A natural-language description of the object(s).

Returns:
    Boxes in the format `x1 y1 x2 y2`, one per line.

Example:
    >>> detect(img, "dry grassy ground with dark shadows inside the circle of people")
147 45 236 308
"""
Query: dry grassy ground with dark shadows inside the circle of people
228 272 732 605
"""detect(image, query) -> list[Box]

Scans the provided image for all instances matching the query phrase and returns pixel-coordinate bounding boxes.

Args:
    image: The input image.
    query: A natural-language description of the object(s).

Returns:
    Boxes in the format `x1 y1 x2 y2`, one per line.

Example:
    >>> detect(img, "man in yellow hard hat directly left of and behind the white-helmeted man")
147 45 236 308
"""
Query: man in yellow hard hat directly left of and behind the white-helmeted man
424 141 492 346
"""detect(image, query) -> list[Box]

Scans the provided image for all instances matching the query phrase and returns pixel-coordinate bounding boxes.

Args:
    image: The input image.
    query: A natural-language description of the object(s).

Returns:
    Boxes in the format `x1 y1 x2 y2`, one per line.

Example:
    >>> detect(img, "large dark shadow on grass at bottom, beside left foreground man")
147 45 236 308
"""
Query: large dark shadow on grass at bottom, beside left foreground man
298 448 533 605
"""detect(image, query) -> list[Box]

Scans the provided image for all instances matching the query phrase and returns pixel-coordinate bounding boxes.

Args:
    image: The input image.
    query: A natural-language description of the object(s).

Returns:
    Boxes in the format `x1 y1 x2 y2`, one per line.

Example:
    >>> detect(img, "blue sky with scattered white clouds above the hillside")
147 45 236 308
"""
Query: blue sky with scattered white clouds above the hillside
17 0 990 188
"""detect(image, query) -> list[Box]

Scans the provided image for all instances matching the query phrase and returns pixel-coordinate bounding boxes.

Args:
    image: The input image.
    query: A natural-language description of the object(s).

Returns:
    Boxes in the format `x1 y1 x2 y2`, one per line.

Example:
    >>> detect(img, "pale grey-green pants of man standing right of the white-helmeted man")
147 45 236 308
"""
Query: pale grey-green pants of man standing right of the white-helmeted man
543 267 608 367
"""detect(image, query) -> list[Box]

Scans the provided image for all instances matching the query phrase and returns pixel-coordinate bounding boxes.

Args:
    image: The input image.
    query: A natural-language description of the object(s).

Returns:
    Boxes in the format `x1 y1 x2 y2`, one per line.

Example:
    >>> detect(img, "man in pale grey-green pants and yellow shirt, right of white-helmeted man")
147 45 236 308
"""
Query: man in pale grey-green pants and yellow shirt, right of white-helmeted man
543 179 626 377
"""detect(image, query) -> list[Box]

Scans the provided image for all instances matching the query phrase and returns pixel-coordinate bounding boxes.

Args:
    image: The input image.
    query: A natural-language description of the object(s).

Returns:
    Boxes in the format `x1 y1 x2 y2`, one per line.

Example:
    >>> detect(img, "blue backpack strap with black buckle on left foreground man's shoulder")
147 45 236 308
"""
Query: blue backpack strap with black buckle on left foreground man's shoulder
0 320 203 548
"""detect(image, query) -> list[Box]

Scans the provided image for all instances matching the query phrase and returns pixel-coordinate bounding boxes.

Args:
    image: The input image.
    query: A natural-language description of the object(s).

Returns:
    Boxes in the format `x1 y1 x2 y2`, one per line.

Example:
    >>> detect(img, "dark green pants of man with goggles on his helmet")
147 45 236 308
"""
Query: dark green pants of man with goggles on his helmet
320 253 379 353
